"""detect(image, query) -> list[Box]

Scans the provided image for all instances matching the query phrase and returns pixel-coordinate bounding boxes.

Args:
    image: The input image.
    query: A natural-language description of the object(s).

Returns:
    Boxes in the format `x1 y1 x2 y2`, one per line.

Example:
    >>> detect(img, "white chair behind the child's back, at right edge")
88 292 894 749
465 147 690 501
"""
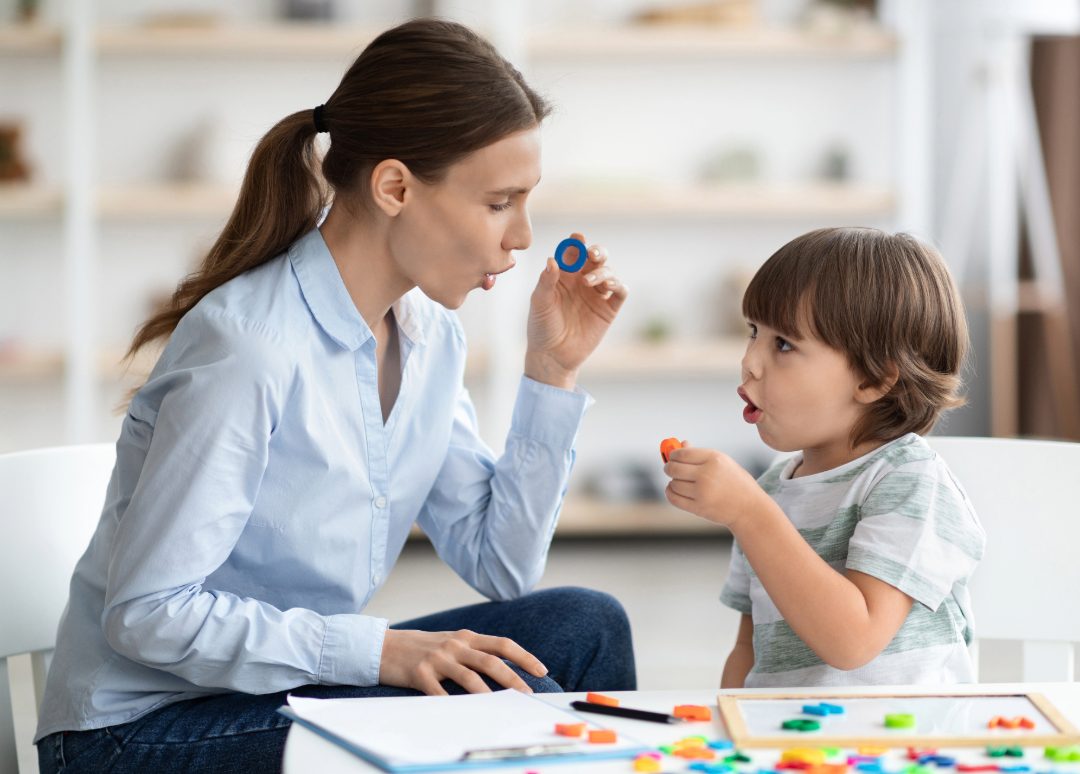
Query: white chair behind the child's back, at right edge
927 436 1080 682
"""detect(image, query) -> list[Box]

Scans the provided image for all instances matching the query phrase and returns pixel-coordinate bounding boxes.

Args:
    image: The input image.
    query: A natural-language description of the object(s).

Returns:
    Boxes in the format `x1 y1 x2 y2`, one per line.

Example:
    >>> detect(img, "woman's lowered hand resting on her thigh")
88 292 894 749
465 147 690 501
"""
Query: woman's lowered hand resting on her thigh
379 629 548 696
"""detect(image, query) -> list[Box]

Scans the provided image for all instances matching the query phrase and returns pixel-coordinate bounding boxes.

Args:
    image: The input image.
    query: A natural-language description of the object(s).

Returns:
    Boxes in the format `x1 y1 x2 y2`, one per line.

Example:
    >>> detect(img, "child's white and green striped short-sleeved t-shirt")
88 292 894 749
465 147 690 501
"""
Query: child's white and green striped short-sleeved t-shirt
720 433 986 688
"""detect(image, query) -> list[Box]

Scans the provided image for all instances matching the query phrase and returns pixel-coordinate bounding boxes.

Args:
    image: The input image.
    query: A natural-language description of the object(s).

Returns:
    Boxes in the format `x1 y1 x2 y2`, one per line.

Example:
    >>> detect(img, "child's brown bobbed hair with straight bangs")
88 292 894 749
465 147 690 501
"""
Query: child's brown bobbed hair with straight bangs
743 228 968 446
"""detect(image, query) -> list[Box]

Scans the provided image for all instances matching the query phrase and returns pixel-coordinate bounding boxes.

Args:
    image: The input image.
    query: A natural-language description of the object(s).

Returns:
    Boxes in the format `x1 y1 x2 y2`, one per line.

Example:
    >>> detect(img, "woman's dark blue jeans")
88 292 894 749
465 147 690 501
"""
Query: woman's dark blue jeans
38 587 636 774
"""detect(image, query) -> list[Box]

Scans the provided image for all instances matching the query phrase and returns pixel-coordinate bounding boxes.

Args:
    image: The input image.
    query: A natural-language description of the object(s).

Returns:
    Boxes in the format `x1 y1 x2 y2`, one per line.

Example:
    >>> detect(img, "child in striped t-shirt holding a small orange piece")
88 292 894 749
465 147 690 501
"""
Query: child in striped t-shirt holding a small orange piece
664 229 986 688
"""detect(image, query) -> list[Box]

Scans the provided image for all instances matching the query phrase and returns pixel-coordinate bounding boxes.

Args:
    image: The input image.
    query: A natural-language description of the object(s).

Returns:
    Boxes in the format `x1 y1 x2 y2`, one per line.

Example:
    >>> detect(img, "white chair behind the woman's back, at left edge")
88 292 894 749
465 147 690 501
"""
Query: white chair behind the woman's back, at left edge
0 444 116 774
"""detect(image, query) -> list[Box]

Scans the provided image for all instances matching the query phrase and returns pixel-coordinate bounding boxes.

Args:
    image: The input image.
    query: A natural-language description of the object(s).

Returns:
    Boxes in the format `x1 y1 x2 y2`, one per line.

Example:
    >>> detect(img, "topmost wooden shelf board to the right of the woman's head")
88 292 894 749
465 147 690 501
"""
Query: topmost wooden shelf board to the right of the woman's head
528 25 897 59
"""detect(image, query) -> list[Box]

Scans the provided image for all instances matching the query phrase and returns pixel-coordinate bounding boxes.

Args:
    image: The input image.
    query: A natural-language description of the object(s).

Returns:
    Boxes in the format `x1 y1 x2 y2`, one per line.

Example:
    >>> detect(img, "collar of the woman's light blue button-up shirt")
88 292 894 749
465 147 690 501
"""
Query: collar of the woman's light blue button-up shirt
288 229 429 351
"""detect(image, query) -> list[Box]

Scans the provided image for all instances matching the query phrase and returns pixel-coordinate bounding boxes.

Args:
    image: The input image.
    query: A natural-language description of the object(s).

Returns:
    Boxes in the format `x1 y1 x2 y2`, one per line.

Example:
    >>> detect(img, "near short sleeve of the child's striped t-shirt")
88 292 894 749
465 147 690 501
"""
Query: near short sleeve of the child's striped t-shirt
847 458 986 610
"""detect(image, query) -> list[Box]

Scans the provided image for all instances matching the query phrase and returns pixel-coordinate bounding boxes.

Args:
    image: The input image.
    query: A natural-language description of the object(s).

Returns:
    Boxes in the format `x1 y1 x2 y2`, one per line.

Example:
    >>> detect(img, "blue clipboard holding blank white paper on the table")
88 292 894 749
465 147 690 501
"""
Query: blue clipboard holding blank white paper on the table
278 690 652 773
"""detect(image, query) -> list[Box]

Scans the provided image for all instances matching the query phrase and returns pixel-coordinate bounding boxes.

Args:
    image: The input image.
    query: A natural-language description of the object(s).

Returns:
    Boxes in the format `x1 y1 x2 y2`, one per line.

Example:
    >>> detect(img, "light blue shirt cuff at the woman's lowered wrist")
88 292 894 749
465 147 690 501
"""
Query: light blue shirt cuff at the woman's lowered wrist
319 614 389 687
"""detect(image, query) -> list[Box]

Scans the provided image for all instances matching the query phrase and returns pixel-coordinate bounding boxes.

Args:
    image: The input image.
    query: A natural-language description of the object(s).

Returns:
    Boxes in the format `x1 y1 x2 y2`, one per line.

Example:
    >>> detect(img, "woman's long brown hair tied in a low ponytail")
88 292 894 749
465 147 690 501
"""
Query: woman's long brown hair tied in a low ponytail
127 18 551 358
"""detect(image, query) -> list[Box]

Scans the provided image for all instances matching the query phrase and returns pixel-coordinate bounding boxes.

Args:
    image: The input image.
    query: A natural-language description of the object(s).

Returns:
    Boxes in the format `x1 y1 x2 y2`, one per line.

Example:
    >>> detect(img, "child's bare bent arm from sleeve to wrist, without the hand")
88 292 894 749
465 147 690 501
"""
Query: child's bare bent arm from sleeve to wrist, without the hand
731 489 913 669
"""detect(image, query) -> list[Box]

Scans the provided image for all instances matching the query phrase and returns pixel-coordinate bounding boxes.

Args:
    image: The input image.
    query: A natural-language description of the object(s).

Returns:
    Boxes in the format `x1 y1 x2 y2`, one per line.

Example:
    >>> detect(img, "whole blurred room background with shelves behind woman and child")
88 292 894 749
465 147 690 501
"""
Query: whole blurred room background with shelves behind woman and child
0 0 1080 688
